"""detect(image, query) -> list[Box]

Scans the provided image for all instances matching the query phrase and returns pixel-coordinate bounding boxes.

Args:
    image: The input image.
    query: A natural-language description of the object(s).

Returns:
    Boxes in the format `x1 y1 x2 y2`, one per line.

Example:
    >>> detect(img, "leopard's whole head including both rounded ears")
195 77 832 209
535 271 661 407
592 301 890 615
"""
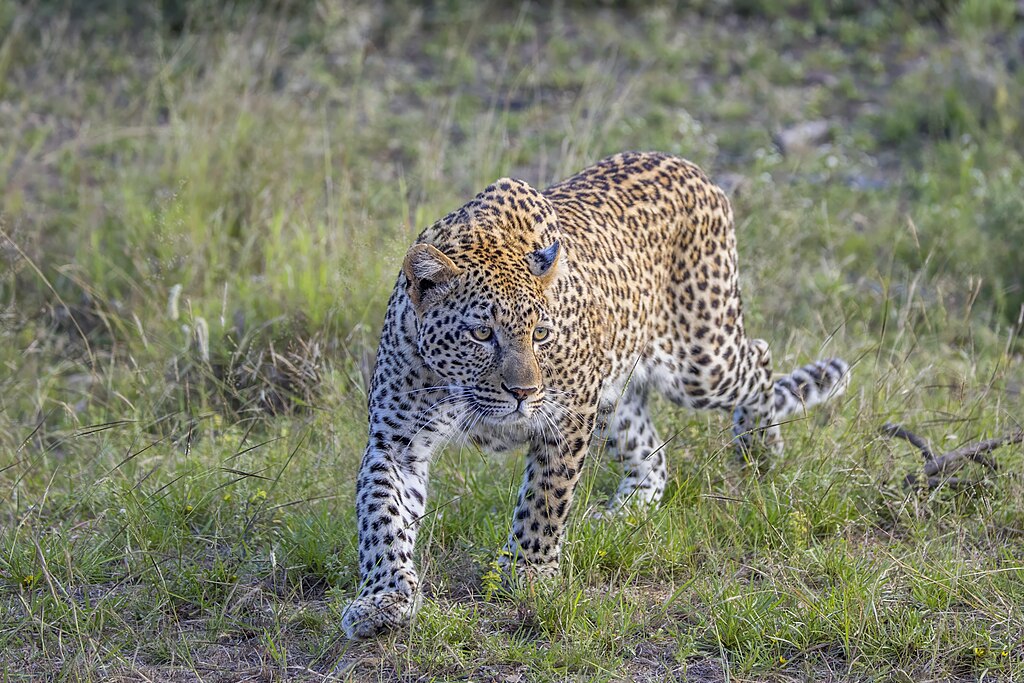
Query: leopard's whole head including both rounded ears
402 236 560 425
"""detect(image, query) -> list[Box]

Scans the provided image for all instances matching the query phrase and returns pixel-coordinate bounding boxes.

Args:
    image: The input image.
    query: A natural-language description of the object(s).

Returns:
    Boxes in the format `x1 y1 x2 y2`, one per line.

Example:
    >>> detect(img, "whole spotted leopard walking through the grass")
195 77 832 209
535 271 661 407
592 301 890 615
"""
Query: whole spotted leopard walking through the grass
342 152 850 639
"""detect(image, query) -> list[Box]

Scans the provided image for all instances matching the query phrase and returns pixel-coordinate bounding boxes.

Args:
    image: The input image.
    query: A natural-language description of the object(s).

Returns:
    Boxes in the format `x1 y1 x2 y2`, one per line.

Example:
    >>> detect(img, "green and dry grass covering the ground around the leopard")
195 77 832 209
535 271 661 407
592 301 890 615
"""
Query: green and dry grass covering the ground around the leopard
0 0 1024 681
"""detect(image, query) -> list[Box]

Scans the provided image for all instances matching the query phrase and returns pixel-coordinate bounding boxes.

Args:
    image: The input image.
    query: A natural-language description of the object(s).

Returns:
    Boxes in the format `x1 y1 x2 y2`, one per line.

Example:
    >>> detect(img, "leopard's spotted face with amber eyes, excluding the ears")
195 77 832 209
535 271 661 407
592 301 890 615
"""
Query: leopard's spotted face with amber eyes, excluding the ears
417 267 559 424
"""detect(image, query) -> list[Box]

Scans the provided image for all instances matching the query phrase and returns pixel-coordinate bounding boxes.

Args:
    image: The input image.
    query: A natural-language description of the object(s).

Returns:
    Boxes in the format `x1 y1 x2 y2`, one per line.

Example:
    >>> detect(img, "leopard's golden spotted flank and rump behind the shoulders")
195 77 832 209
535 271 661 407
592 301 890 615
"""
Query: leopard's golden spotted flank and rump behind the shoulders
544 153 749 408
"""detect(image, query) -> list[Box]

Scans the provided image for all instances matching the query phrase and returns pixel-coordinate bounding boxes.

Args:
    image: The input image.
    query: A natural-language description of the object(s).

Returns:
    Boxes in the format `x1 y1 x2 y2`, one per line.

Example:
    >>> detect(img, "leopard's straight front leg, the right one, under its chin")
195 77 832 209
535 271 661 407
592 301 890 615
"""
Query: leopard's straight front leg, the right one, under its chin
500 405 596 581
